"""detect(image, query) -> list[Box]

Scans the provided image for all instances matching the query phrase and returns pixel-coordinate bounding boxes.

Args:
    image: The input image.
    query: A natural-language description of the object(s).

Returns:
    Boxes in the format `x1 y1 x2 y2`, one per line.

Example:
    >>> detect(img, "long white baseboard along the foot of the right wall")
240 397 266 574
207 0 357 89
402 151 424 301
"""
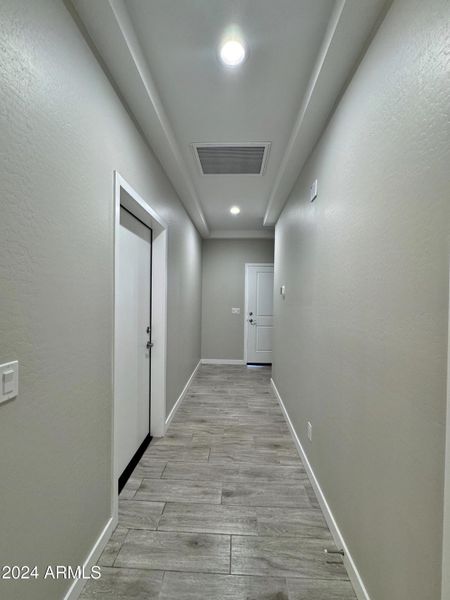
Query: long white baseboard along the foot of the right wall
270 379 370 600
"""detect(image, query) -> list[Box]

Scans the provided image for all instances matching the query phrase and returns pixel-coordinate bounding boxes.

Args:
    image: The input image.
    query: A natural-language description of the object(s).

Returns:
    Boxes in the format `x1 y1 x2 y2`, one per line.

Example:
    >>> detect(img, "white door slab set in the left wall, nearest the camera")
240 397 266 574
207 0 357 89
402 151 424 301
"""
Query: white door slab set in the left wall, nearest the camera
114 208 151 476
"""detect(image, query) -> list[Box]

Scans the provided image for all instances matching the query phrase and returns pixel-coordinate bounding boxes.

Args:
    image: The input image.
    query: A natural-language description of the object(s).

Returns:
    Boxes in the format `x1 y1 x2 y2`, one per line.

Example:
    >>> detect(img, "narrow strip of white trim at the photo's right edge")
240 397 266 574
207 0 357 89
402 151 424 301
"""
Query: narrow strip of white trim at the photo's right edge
441 266 450 600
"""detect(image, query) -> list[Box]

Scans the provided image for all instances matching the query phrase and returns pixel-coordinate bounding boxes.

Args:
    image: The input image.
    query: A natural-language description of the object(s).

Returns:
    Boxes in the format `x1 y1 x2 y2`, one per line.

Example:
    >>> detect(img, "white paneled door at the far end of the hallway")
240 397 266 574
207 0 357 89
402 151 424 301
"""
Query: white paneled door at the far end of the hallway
245 264 273 363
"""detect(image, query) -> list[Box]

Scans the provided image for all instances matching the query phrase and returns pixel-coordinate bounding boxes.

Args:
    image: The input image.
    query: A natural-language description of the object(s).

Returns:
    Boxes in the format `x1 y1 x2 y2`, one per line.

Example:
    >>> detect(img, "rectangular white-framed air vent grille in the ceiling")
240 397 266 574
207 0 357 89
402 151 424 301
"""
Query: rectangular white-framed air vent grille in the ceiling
193 142 270 175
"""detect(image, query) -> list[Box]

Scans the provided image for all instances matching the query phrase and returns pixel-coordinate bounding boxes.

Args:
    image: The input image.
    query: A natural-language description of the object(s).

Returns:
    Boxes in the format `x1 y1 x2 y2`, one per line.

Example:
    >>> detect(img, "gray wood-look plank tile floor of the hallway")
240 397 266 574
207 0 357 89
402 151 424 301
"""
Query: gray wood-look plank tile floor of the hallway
81 365 356 600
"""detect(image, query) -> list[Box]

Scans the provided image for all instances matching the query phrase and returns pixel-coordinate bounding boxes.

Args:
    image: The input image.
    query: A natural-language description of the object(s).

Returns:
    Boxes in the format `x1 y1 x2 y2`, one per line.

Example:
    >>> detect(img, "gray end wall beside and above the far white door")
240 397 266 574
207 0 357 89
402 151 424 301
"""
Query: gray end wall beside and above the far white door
202 239 273 360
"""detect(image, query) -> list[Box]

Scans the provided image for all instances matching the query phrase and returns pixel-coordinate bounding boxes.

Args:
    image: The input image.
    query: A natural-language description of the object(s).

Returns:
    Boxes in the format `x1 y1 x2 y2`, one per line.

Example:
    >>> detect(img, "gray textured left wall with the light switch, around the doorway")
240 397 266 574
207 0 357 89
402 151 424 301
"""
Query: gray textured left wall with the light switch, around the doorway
0 0 201 600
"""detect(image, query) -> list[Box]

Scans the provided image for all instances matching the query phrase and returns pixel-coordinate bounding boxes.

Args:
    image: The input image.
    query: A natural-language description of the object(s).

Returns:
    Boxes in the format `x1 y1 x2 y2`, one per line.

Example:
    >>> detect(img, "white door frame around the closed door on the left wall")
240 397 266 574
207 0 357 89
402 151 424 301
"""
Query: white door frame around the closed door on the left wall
111 171 167 525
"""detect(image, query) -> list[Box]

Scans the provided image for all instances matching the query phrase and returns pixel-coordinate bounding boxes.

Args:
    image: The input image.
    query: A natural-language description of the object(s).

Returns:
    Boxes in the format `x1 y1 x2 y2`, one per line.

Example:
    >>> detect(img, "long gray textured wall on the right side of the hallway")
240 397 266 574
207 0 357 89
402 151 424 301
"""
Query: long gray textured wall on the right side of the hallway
274 0 450 600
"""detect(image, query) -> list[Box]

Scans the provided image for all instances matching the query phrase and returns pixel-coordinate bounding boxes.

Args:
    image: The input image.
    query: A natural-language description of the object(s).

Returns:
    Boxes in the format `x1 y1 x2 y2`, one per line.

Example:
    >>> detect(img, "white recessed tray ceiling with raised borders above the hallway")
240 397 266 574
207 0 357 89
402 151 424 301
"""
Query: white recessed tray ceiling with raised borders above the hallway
73 0 385 237
